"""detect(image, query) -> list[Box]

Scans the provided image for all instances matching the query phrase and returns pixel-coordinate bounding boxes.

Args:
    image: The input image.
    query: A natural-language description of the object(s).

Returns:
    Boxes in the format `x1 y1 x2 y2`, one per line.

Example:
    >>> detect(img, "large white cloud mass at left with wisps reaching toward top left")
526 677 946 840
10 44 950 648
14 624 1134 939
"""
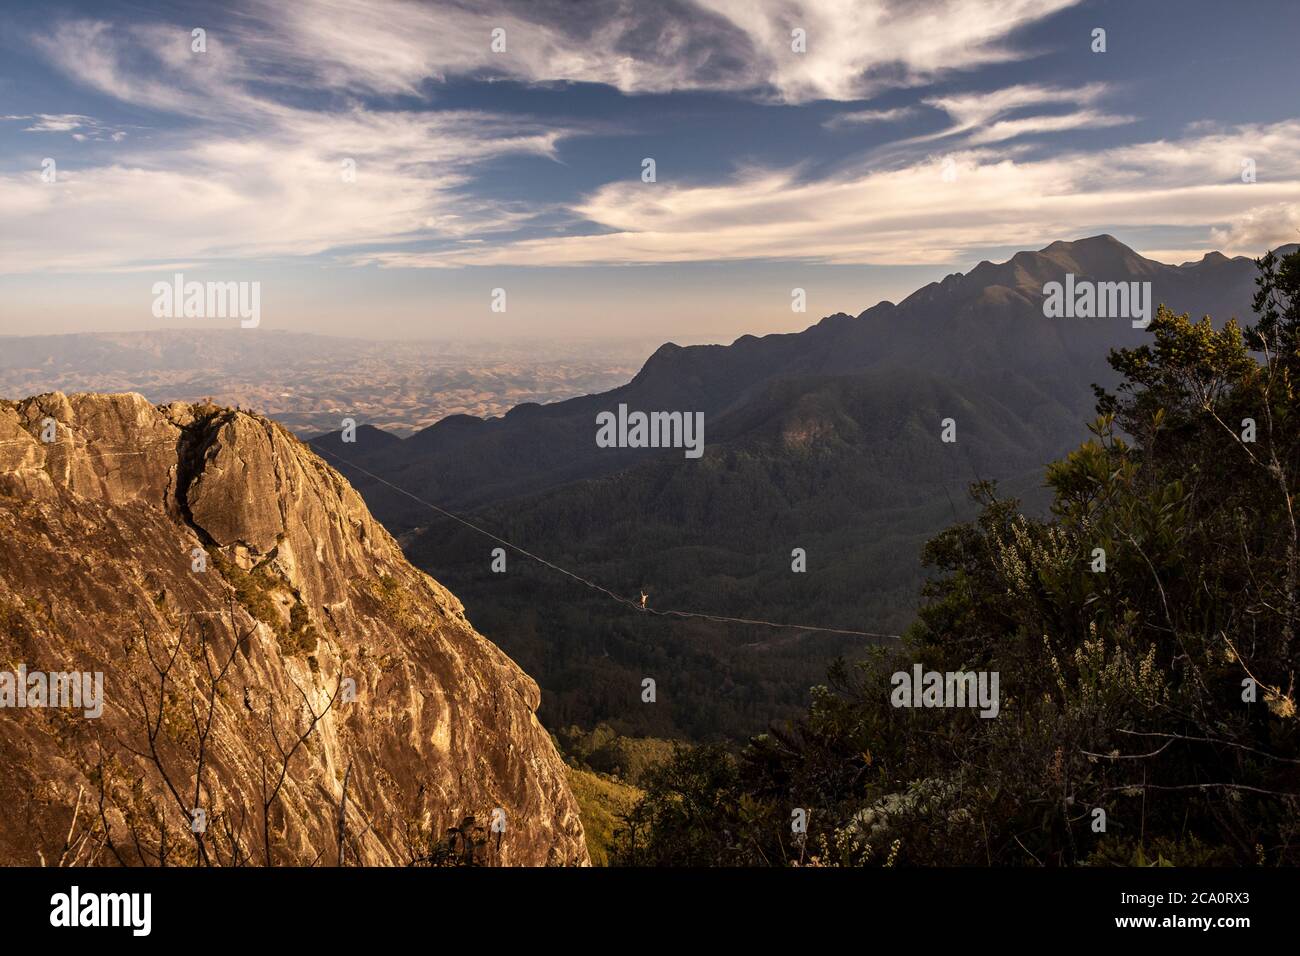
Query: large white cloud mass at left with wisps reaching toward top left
0 14 571 272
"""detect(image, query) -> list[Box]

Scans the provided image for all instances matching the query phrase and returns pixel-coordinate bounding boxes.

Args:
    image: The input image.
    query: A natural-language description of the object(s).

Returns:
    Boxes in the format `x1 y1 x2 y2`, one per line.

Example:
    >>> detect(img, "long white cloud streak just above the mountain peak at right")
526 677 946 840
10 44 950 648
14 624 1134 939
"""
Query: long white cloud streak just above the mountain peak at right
363 121 1300 267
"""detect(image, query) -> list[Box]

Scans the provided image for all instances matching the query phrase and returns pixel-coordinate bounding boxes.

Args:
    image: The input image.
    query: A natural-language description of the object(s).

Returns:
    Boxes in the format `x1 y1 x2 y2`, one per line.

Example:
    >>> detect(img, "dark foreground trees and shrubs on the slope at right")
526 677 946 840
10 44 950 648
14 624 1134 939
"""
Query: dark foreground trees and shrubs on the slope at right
612 254 1300 866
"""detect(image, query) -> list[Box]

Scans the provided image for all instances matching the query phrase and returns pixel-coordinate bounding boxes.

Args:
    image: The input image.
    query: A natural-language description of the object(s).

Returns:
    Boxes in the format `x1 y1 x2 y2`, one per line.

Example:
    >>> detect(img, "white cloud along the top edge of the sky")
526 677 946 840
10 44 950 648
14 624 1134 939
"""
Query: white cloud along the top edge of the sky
218 0 1079 103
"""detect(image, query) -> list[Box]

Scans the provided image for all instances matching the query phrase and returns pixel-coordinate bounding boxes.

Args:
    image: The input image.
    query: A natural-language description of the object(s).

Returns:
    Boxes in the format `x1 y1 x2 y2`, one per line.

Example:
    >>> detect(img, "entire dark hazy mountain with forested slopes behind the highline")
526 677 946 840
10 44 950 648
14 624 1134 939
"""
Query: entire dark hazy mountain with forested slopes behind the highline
306 235 1279 739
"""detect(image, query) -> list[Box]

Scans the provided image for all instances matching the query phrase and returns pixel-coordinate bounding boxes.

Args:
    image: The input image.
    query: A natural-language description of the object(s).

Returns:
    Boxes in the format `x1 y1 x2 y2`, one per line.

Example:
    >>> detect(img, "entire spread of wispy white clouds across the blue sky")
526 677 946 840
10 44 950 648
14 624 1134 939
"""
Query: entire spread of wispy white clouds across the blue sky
0 0 1300 280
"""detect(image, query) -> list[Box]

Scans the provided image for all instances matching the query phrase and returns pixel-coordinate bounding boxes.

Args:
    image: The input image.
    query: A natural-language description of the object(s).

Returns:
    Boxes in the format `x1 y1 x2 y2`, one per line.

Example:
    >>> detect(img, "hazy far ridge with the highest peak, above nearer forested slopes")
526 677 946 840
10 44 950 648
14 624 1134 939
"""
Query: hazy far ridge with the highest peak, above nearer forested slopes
311 234 1255 532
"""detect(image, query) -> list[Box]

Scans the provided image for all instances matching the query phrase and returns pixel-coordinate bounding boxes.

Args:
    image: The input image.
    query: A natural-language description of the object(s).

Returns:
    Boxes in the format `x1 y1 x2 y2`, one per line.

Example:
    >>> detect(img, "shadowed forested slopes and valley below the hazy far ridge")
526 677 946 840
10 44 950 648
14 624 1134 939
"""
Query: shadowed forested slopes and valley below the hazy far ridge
404 373 1086 741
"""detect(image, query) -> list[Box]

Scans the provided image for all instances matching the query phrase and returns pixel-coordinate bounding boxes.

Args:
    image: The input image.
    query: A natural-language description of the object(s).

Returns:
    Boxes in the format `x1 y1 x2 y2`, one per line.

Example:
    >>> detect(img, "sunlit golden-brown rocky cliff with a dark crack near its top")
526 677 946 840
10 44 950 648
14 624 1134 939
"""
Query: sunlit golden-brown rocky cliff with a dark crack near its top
0 393 588 865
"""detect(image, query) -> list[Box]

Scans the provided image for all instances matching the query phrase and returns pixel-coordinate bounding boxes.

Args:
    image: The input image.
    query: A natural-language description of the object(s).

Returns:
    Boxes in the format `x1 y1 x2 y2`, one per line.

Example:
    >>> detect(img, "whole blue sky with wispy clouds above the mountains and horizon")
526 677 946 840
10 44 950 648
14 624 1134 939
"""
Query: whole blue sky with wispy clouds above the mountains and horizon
0 0 1300 341
